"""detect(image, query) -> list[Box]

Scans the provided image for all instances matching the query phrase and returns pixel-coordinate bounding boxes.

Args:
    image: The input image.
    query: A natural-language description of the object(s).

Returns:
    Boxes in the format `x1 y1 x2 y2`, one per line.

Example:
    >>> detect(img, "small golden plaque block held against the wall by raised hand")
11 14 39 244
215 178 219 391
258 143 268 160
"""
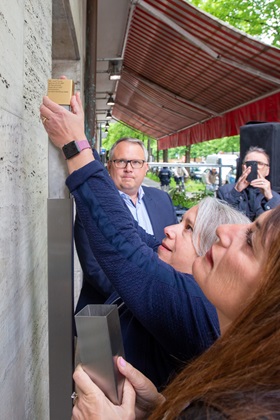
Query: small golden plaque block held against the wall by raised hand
47 79 75 107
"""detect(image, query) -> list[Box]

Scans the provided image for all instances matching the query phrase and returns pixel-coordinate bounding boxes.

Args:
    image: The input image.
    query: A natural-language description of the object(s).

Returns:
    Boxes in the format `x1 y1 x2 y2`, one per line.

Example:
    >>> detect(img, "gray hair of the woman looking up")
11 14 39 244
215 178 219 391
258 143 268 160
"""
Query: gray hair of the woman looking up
192 197 251 256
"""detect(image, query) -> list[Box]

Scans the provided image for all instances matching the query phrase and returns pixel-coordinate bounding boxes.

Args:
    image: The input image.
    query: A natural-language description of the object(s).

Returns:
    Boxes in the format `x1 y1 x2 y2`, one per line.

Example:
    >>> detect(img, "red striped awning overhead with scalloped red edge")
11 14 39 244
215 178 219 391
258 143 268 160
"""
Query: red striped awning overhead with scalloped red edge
113 0 280 149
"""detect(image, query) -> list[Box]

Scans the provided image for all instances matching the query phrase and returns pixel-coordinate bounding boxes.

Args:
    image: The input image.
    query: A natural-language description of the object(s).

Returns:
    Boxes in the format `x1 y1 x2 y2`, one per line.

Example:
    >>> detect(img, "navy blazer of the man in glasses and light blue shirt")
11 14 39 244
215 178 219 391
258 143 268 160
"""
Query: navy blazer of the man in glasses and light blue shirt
74 186 177 313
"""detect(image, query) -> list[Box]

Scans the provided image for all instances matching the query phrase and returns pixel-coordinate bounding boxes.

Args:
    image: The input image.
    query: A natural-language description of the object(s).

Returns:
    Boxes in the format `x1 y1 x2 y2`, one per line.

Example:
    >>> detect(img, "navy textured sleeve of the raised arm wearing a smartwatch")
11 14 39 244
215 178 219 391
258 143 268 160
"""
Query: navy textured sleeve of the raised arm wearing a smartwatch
66 161 219 359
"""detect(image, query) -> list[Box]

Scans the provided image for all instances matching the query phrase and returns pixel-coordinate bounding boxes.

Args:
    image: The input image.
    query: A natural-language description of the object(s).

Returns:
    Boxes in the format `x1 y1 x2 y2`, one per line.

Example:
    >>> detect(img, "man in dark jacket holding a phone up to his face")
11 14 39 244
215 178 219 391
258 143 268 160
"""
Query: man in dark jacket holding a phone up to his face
217 147 280 221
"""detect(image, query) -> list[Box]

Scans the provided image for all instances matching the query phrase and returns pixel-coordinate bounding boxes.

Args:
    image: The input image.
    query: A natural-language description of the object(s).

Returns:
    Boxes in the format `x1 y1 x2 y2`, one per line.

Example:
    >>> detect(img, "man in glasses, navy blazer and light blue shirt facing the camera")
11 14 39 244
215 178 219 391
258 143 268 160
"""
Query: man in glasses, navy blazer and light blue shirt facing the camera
74 137 177 313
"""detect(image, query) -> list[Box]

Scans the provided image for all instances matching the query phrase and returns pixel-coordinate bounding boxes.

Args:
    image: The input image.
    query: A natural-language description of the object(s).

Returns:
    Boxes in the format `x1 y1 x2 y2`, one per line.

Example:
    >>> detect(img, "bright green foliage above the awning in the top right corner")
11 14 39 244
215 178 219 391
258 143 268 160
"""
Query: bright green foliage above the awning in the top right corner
189 0 280 47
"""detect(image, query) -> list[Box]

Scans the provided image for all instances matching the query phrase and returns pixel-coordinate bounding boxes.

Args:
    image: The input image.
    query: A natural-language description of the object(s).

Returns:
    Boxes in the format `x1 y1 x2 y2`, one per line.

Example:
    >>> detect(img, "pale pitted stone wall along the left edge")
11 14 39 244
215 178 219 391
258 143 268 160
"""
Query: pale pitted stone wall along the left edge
0 0 85 420
